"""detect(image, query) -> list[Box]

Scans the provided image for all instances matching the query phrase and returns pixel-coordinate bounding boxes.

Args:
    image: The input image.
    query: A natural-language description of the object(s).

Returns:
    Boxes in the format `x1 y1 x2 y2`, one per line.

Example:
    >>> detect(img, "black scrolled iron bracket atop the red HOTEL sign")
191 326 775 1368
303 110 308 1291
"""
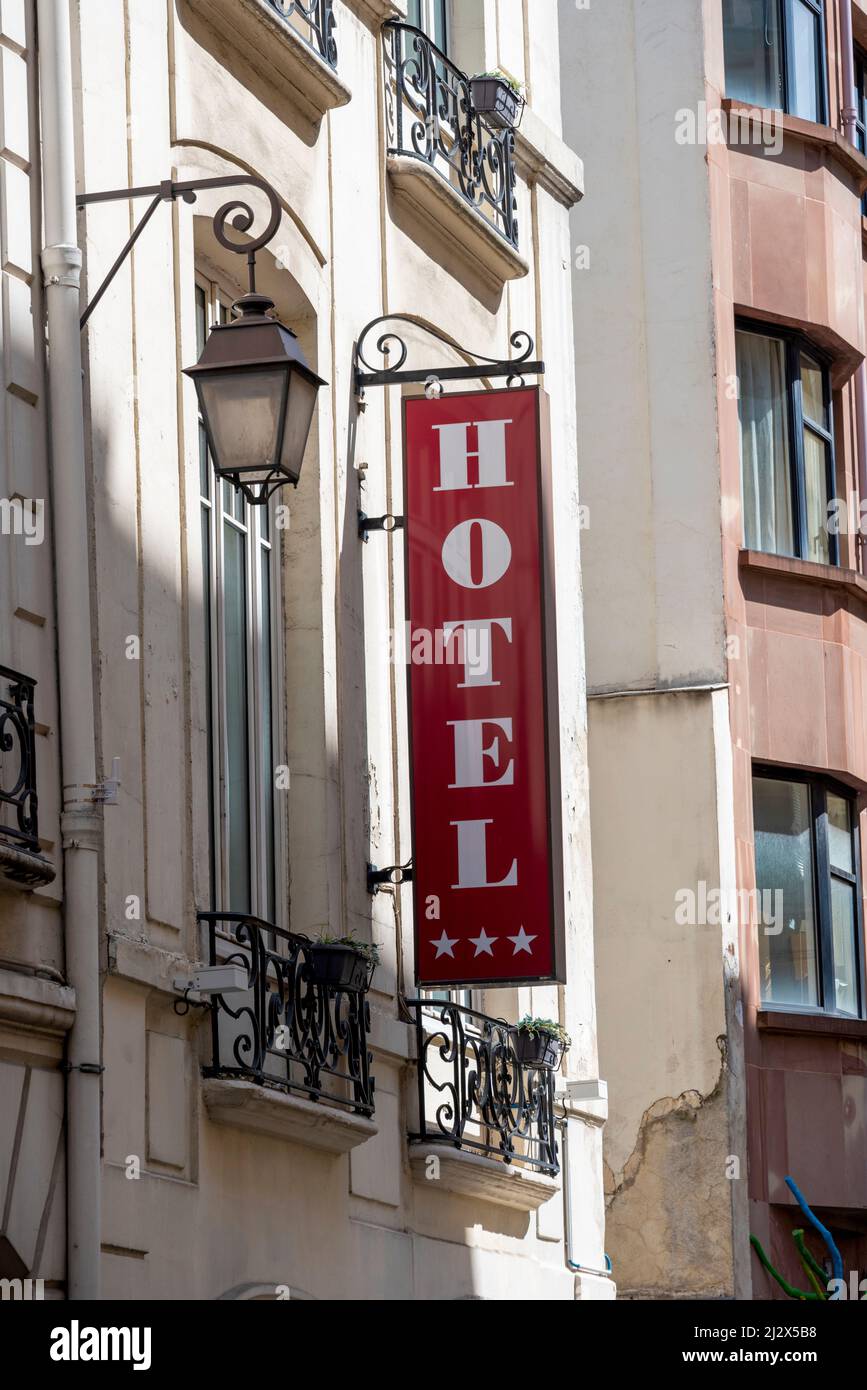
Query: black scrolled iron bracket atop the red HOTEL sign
353 314 545 403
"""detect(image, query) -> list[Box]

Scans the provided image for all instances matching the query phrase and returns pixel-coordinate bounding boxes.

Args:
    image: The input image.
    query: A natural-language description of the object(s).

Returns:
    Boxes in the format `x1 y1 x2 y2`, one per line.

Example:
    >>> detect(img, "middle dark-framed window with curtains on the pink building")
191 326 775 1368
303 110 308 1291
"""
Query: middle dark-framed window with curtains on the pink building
735 325 839 564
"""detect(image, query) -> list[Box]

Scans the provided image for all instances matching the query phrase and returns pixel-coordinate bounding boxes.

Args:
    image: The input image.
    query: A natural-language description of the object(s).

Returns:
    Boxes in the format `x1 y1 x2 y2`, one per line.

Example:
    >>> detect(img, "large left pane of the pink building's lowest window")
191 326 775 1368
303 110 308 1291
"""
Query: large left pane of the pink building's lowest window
753 777 818 1006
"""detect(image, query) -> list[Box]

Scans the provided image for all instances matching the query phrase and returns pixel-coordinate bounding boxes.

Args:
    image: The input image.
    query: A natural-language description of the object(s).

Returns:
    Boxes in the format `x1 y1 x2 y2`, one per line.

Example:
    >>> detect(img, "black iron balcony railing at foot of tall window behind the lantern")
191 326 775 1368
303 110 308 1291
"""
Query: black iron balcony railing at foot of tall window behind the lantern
199 912 374 1115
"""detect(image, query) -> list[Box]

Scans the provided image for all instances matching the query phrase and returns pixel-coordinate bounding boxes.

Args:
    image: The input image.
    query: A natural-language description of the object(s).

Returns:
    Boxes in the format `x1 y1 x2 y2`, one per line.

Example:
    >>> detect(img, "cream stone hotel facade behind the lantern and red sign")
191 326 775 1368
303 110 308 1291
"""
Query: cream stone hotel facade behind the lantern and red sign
0 0 614 1300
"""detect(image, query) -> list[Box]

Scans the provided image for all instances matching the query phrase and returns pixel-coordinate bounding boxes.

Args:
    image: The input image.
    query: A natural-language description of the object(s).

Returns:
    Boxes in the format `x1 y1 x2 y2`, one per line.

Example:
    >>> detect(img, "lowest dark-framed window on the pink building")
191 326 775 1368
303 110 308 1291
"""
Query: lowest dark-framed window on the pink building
753 770 863 1017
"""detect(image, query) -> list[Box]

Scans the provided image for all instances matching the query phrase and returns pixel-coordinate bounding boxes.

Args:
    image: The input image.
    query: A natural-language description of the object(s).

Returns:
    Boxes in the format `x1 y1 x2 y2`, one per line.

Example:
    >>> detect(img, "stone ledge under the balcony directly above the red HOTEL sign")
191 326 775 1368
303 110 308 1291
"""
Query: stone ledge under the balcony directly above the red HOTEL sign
386 154 529 292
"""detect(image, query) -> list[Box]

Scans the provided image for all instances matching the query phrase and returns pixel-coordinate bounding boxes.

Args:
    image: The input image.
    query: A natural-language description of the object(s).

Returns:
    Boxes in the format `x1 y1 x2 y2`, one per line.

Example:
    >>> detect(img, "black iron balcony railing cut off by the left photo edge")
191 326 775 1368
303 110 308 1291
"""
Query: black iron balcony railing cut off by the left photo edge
0 666 39 853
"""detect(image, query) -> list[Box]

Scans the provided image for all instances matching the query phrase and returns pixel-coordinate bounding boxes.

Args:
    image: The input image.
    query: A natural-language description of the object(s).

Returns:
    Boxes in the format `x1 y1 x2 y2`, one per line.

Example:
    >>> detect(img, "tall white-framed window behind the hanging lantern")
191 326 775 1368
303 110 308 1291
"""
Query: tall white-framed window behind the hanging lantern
196 281 279 922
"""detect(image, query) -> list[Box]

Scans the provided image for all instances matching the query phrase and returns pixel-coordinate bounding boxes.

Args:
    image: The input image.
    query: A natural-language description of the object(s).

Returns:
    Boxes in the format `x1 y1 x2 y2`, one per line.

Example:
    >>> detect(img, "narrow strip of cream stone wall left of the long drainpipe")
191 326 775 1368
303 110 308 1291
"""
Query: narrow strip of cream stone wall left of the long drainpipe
0 0 67 1297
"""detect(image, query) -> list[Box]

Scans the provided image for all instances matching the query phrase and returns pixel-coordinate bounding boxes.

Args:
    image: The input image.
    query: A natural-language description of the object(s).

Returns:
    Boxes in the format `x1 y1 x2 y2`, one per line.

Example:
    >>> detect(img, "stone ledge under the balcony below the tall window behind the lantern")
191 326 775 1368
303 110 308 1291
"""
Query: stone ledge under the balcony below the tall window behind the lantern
201 1076 378 1155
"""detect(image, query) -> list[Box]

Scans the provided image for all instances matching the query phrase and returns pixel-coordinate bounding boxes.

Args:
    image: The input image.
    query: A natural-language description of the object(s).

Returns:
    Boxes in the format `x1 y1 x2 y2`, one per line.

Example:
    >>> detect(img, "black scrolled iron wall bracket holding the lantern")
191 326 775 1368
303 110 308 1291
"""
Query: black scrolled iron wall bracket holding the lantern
75 174 282 328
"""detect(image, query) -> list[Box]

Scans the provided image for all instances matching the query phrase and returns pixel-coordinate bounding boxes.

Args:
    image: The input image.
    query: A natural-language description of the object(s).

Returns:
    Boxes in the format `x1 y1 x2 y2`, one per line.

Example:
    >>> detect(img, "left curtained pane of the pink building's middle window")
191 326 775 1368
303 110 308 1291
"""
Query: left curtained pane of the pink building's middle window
736 332 795 555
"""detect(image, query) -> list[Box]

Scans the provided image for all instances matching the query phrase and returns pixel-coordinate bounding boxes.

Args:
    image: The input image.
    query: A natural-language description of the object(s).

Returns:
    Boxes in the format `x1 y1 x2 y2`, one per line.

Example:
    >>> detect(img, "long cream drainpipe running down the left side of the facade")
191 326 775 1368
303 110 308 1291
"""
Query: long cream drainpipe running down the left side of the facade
36 0 101 1298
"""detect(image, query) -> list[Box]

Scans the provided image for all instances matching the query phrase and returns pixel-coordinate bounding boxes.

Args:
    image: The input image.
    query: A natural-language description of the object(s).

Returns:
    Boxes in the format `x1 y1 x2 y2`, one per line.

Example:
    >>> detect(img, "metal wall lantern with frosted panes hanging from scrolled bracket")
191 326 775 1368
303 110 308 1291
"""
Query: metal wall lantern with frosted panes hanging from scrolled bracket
183 289 325 503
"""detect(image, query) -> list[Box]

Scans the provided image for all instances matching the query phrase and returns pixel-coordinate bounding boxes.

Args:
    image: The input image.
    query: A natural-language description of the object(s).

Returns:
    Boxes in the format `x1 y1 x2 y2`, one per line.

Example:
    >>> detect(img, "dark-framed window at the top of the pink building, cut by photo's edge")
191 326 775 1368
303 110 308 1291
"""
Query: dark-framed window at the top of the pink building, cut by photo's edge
723 0 827 122
